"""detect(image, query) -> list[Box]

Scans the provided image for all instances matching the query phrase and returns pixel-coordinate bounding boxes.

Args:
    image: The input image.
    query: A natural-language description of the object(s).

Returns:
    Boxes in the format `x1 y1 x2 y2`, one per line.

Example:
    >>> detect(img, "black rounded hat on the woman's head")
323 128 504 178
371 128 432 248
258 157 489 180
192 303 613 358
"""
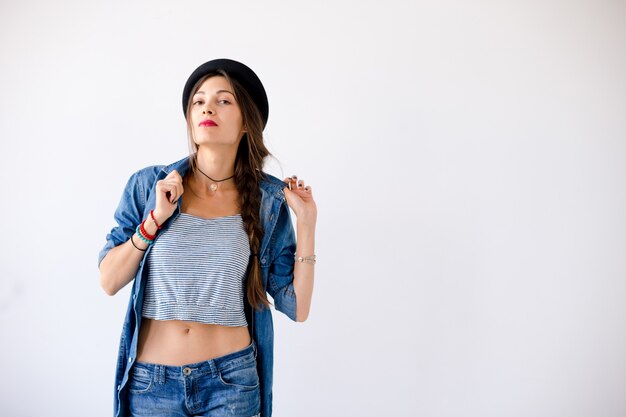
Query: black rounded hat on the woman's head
183 58 269 127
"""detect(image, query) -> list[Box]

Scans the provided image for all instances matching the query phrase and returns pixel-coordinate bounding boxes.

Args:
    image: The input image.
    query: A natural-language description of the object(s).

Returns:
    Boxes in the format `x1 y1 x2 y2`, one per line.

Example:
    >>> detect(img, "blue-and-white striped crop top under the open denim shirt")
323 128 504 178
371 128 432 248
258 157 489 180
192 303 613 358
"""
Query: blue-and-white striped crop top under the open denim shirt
142 213 250 326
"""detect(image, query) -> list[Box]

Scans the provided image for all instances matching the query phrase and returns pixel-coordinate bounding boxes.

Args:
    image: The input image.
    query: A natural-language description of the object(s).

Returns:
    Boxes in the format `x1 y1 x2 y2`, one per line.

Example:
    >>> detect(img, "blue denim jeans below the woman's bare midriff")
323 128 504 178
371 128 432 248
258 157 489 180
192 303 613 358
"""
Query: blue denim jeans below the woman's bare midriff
128 340 261 417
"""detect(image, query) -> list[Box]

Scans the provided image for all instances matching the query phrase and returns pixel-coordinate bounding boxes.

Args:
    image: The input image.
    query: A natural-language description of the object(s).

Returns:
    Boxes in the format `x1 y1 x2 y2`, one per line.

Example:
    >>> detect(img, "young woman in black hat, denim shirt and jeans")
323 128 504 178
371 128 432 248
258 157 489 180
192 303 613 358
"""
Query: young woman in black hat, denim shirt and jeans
99 59 317 417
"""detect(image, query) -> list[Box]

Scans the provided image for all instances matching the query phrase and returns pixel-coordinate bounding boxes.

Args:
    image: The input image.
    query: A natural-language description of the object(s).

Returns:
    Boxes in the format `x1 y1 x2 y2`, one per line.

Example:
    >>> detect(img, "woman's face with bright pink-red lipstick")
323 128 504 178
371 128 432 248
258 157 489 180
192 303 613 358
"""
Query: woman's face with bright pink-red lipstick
190 75 245 146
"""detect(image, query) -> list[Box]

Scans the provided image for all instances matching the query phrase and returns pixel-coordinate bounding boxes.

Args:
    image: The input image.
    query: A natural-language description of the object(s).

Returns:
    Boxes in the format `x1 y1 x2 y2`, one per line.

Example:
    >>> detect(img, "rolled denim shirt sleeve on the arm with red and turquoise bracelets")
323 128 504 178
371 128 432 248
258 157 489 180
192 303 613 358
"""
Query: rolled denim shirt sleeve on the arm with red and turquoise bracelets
98 171 146 267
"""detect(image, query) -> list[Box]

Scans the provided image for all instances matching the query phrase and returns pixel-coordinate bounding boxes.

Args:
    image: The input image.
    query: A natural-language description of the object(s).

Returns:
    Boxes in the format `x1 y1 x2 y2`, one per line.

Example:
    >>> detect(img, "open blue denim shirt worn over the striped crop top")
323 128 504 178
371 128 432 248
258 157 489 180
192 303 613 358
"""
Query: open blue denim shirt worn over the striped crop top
98 157 296 417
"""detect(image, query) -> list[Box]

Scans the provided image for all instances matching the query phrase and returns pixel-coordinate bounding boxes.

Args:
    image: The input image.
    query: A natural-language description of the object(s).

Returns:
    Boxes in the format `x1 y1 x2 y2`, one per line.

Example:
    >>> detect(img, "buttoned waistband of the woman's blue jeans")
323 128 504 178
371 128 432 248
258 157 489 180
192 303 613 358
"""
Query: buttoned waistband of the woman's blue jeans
133 340 257 381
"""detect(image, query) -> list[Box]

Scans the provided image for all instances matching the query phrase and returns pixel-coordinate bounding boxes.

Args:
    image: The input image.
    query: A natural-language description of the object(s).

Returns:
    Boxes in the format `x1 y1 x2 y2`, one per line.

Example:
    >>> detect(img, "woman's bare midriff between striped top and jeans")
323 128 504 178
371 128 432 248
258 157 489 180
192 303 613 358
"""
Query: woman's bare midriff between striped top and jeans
137 317 252 366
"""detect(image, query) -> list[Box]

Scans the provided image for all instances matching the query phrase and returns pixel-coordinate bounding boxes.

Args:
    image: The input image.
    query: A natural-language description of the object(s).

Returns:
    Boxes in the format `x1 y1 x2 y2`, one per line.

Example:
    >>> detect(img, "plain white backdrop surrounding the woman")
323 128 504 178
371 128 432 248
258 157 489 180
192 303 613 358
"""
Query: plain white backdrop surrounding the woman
0 0 626 417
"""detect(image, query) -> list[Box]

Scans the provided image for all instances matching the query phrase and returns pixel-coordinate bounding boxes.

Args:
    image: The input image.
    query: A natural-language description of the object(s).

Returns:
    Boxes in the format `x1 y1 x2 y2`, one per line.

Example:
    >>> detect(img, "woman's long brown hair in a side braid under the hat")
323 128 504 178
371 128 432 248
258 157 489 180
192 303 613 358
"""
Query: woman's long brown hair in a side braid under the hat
187 70 271 310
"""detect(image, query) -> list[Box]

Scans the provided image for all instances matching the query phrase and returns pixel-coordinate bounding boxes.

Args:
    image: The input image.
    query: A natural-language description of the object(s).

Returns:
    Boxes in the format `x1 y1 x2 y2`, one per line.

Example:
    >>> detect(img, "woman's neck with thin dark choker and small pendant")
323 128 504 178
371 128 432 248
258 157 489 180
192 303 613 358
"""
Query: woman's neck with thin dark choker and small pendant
194 146 237 191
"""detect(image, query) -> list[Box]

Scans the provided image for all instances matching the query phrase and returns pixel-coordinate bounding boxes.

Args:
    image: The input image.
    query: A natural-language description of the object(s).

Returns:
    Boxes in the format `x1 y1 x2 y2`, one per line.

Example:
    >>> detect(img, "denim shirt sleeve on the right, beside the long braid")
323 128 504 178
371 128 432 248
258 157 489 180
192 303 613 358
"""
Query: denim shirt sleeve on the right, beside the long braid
267 203 296 321
